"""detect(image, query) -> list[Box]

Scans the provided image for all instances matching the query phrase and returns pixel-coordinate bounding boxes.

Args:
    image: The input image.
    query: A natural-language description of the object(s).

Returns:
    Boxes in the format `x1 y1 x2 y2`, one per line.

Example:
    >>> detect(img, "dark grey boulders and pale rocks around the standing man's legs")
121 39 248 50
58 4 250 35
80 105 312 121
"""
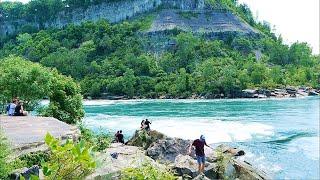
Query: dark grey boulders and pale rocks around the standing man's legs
129 131 269 180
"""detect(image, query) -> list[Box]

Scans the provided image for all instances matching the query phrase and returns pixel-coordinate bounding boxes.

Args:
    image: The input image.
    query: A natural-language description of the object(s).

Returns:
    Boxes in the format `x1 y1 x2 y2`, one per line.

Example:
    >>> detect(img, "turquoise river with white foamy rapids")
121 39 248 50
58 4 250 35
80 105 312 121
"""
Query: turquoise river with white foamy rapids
84 97 320 179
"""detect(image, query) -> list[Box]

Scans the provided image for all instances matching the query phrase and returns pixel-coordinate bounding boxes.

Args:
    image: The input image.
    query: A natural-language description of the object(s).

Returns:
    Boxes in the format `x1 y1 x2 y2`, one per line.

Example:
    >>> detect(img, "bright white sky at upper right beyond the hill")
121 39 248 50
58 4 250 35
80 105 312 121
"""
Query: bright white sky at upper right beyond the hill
0 0 320 54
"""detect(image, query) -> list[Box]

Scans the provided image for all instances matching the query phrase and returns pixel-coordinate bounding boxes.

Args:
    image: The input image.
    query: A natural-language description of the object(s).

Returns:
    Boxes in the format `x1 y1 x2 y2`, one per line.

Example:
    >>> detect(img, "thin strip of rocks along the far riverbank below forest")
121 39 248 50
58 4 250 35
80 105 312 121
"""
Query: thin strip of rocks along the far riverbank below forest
86 87 320 100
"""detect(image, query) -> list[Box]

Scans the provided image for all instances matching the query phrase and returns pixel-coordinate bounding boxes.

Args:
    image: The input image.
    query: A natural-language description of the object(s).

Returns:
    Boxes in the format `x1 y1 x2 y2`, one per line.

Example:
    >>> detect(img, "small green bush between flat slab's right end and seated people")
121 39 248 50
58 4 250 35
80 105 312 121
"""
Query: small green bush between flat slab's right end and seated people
79 124 112 151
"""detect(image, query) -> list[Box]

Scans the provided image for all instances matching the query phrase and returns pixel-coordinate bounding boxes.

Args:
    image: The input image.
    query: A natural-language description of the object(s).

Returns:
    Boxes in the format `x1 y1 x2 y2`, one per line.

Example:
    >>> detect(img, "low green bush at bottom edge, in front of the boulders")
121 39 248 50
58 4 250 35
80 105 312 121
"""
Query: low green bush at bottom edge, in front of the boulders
121 162 177 180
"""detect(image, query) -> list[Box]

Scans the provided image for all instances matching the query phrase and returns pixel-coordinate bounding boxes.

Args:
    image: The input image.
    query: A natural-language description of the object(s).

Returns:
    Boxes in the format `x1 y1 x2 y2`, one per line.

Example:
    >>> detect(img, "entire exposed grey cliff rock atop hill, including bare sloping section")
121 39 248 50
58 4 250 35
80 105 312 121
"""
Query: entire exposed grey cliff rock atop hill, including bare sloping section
0 0 257 37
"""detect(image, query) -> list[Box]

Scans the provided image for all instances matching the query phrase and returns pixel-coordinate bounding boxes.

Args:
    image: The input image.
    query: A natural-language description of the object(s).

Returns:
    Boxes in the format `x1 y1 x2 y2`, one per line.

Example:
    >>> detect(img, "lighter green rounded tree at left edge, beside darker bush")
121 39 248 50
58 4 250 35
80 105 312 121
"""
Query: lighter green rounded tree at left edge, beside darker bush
0 56 51 110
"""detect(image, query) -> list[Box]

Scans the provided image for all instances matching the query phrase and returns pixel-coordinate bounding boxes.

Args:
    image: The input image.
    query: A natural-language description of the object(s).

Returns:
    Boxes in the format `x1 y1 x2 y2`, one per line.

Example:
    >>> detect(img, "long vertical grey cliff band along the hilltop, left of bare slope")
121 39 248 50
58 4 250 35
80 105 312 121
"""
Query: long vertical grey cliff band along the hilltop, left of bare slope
0 0 205 36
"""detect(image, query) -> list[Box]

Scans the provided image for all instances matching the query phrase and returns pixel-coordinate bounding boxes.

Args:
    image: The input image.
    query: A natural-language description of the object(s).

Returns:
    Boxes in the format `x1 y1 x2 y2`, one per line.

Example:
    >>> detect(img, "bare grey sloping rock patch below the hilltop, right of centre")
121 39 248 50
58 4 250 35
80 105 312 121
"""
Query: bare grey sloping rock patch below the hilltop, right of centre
148 9 258 34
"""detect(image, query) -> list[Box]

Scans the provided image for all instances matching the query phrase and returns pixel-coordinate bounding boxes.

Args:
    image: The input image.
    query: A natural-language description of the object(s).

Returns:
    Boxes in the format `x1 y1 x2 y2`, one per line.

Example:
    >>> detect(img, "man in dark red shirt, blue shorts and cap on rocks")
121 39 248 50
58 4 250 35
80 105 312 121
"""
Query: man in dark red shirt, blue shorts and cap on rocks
189 135 211 174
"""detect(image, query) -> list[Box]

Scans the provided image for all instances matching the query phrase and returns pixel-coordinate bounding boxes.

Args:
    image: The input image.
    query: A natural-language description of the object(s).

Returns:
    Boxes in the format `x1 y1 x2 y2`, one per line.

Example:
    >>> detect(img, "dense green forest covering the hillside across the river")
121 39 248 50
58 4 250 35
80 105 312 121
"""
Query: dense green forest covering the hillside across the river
0 0 320 98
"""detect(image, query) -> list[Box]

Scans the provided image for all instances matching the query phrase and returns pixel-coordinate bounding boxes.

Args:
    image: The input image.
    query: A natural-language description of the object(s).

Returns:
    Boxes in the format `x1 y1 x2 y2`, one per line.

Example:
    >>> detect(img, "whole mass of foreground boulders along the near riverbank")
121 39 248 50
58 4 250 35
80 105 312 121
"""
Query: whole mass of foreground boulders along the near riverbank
87 131 270 180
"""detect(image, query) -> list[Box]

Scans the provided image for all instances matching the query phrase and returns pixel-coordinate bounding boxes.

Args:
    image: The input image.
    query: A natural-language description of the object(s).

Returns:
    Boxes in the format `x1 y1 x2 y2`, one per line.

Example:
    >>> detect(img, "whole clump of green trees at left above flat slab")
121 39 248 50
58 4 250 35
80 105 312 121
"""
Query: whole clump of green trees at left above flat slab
0 56 84 123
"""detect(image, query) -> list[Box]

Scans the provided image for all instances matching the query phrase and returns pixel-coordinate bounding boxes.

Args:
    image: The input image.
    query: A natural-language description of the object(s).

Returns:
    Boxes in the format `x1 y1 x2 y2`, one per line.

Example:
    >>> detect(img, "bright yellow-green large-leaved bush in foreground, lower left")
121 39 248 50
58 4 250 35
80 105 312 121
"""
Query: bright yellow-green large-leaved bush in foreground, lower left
43 134 96 180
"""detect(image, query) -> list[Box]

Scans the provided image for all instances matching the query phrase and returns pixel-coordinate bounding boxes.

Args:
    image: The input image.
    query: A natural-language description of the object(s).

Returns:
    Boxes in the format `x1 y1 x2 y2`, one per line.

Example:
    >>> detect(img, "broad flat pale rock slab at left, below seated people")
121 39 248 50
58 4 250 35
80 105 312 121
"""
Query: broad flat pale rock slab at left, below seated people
0 116 80 156
